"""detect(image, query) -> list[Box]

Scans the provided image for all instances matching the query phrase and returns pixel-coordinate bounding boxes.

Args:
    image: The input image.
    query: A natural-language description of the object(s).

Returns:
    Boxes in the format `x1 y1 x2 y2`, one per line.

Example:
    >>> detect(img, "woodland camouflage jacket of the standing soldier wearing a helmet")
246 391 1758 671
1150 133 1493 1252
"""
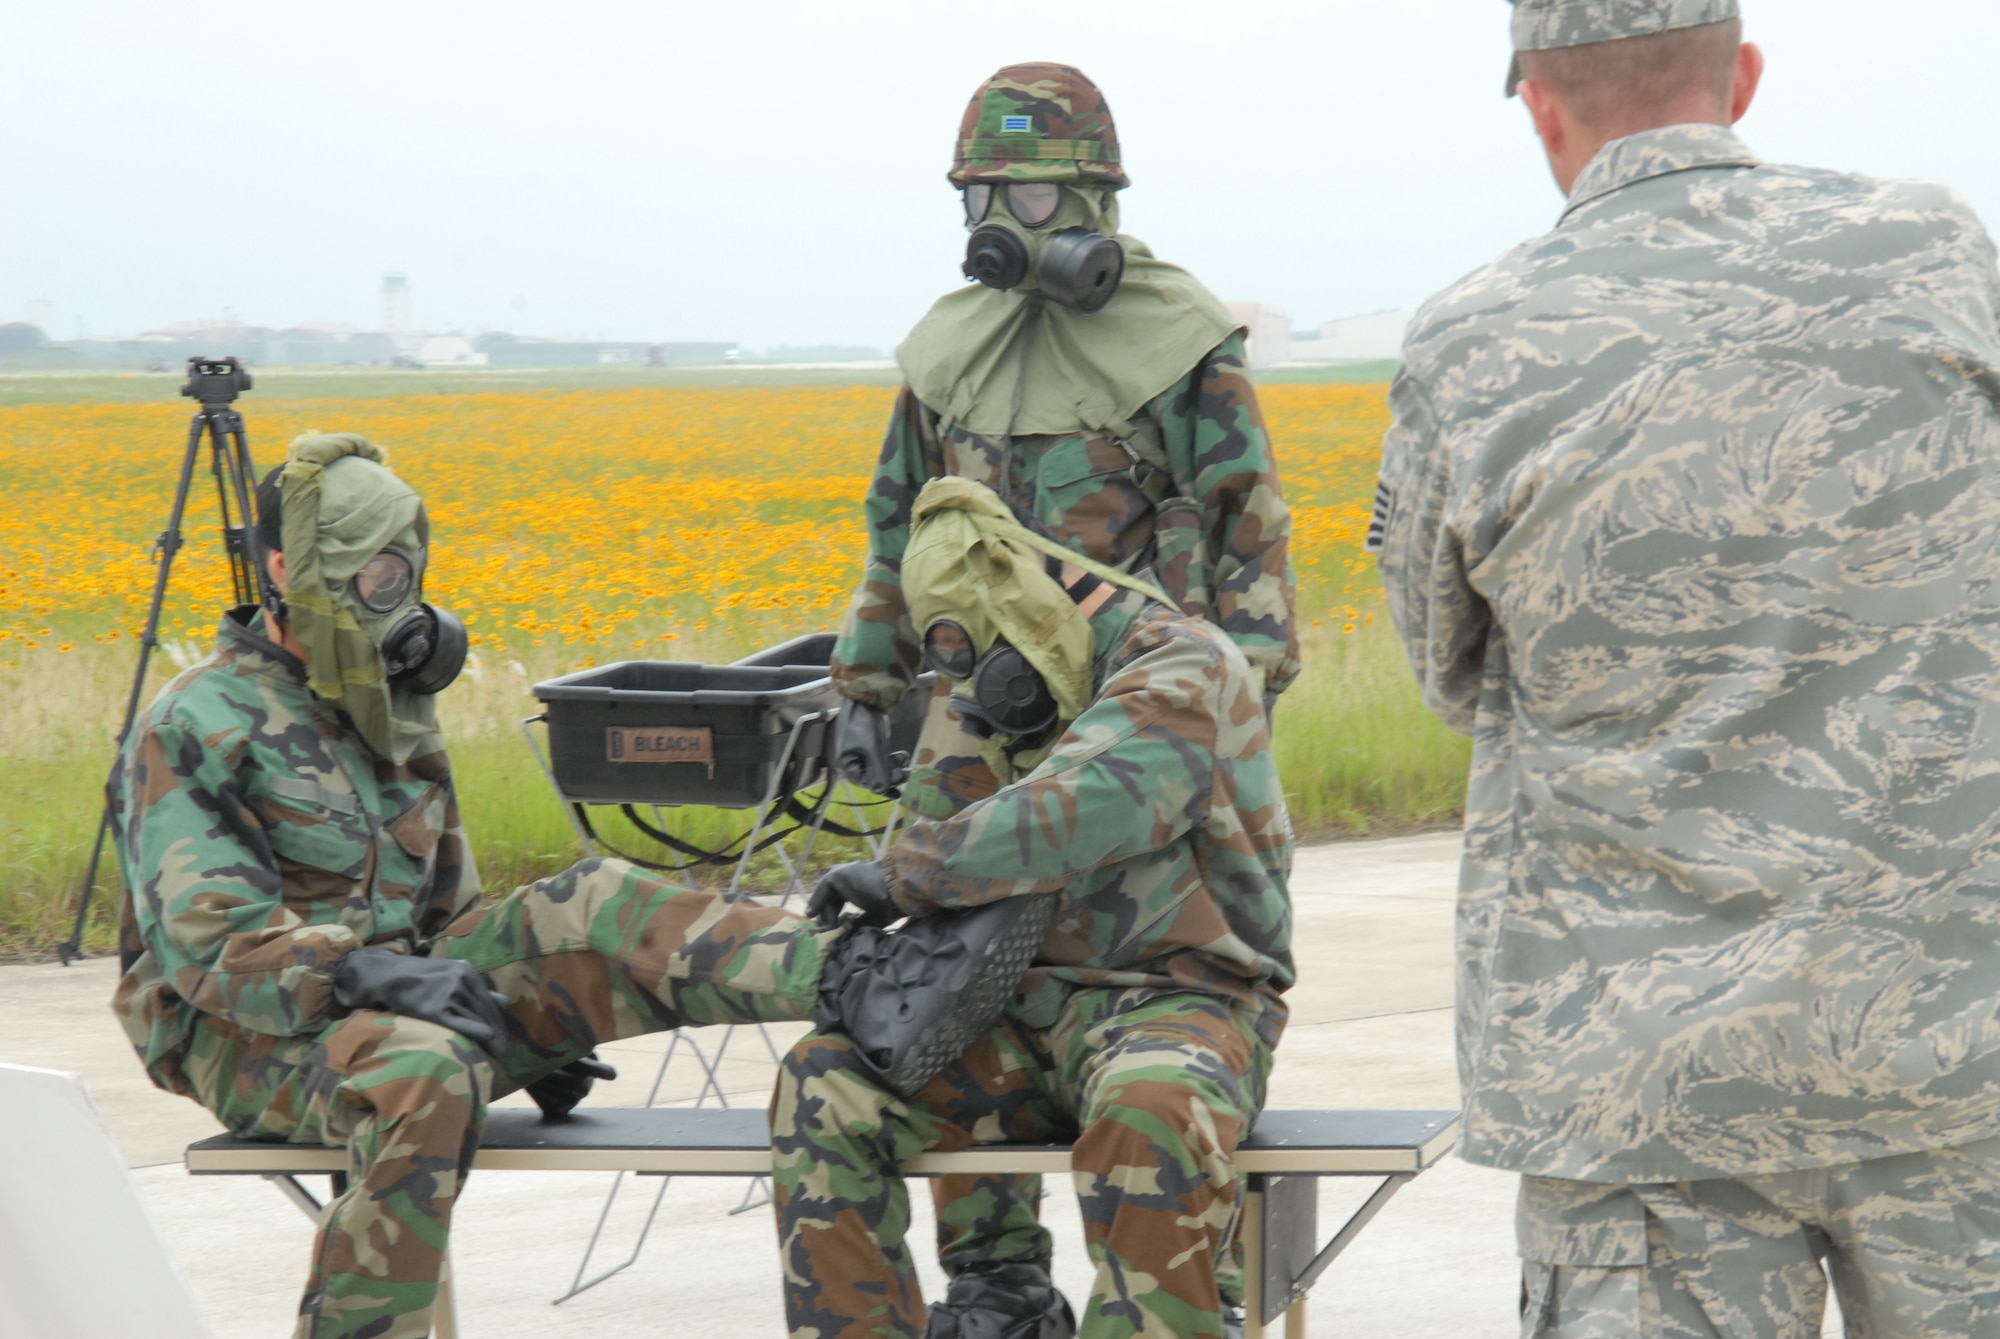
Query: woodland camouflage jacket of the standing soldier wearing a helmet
834 336 1298 707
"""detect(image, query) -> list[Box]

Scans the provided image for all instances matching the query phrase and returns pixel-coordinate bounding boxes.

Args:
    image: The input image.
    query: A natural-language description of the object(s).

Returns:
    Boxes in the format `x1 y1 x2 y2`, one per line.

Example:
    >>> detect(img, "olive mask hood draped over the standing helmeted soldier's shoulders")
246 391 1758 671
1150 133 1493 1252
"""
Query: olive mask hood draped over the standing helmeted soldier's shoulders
896 188 1238 438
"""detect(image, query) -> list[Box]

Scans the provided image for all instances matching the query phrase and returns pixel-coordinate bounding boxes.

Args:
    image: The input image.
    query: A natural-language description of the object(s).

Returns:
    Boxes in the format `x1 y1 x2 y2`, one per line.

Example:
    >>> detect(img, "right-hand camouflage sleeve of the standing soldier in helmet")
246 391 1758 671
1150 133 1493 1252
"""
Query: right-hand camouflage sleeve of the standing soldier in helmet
1160 334 1298 693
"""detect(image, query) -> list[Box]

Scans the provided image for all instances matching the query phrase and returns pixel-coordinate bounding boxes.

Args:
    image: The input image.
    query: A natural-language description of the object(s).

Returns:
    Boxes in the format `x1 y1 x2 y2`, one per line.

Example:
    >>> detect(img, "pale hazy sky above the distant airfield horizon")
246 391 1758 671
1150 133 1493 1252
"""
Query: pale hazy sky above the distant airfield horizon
0 0 2000 348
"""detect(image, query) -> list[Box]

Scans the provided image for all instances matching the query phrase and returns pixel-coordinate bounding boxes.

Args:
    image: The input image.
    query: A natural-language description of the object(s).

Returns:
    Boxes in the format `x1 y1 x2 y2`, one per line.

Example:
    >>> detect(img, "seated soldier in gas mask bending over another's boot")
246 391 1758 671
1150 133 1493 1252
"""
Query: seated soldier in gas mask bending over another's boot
772 478 1292 1339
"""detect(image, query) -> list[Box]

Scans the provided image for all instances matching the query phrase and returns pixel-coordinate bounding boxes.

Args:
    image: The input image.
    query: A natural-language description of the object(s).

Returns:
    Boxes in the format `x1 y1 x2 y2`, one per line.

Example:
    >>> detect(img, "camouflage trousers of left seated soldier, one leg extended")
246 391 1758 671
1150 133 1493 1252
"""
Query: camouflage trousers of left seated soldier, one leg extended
186 859 820 1339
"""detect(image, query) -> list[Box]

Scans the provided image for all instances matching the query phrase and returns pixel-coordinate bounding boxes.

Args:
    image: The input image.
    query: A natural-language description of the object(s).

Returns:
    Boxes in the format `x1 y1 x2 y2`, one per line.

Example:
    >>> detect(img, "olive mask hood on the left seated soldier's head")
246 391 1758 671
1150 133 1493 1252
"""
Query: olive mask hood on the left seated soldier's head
280 434 438 763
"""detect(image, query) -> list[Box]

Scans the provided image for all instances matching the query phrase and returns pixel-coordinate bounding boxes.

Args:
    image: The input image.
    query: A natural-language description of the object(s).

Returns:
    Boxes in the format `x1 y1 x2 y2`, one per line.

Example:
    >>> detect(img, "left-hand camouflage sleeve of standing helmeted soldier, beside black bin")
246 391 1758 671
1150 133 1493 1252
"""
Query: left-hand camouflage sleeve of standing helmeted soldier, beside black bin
832 386 936 711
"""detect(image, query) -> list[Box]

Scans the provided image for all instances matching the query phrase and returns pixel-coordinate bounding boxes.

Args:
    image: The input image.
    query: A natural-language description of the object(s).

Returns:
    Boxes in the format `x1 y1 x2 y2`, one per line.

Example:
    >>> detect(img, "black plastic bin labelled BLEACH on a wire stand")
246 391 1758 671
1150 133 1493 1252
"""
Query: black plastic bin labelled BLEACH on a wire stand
534 659 840 809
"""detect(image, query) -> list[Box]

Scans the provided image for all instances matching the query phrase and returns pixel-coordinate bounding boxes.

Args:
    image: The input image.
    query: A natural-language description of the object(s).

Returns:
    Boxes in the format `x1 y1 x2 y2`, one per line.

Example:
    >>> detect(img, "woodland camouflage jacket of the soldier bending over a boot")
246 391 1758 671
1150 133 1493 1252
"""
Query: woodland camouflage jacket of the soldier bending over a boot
882 592 1292 1045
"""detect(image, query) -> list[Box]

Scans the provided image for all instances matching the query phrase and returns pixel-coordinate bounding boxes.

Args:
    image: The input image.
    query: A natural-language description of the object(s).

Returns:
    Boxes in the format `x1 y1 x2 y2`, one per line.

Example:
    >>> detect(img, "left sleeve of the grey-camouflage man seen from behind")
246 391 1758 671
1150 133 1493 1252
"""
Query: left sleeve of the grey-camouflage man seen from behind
1370 370 1492 735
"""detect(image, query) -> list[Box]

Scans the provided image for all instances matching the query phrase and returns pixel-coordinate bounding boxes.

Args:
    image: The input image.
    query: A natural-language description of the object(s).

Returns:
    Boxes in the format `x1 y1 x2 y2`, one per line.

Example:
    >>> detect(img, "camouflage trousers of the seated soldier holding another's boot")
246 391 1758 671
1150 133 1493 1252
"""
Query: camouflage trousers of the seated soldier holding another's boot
770 989 1270 1339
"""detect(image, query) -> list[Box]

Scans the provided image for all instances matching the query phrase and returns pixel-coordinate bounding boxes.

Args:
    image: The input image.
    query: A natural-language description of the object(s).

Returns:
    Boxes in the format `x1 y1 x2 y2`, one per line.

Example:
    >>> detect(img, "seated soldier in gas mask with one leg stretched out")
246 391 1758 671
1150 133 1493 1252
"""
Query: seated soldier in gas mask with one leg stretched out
112 436 860 1339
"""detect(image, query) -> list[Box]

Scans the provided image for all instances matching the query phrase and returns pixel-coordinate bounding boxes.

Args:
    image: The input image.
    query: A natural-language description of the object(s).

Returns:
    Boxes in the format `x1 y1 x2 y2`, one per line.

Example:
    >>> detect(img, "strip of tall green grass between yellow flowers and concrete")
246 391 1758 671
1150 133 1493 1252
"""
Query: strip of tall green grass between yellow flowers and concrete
0 620 1468 957
